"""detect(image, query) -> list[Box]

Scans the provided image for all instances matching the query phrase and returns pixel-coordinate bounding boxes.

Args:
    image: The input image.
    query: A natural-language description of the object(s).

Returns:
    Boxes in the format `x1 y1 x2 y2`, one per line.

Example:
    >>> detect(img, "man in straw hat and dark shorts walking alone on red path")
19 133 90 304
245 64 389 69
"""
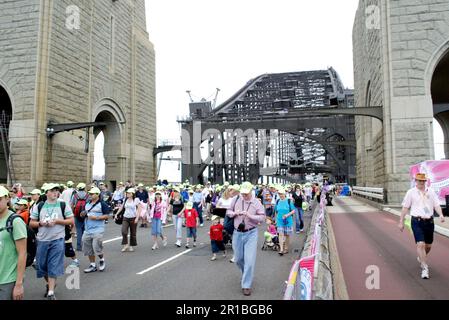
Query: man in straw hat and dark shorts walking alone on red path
398 173 444 279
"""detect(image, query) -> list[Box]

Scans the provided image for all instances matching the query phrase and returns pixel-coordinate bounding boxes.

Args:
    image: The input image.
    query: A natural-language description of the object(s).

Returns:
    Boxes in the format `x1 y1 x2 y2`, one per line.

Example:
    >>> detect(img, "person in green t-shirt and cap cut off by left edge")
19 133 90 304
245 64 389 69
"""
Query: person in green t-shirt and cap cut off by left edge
0 186 27 301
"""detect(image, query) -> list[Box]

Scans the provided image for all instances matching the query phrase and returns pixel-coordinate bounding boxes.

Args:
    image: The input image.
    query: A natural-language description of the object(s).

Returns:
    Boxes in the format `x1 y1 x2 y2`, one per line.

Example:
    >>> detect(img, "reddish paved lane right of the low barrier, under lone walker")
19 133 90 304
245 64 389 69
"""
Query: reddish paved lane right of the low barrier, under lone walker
327 197 449 300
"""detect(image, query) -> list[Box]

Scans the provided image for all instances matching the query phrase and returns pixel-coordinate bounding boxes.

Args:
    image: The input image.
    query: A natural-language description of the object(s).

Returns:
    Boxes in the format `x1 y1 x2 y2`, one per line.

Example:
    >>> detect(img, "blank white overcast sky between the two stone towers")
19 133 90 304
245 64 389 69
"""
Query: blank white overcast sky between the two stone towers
93 0 441 180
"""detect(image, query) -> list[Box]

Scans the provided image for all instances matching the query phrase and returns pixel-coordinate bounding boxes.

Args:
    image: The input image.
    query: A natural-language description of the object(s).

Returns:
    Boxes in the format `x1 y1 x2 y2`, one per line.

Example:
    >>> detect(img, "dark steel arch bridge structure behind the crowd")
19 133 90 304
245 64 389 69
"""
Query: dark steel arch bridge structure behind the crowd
172 68 360 184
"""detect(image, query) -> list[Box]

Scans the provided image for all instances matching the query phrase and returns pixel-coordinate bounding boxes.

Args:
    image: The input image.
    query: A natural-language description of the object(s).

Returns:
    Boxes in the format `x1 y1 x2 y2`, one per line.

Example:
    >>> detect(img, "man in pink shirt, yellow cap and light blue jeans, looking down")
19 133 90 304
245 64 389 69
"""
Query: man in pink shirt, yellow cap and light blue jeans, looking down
226 182 266 296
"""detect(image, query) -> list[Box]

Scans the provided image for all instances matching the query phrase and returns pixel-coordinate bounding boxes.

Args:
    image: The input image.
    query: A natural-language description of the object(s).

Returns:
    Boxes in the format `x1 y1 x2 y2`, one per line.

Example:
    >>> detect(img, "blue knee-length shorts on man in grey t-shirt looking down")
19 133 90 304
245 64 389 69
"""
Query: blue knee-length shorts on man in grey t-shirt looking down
36 238 65 278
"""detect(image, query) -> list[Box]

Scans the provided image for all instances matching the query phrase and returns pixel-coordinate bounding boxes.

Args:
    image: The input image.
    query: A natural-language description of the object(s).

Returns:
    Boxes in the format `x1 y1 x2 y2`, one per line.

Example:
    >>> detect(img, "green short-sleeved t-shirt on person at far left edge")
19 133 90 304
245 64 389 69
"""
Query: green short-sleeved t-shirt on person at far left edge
0 212 27 284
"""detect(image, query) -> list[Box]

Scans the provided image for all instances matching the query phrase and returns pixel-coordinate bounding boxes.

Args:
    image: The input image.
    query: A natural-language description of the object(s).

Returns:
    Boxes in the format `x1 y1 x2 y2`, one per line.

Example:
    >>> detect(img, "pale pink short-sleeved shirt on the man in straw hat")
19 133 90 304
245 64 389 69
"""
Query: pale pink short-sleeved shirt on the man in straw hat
402 187 440 219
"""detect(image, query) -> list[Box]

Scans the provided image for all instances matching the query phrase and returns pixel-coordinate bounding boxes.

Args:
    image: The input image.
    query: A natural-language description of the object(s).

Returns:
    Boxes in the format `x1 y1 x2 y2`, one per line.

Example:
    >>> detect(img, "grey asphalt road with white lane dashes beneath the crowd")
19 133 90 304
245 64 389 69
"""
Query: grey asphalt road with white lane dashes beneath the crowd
24 206 311 300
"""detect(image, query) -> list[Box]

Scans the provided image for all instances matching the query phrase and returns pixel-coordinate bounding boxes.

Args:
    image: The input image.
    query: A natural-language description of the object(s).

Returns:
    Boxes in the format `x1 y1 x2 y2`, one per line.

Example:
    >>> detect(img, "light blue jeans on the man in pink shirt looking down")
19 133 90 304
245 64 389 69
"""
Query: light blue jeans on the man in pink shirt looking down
232 228 258 289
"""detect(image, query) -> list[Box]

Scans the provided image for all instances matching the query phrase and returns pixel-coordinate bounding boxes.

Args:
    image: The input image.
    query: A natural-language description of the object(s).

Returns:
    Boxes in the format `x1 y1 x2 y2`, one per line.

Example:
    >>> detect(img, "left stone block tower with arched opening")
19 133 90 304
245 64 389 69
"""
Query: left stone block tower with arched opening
0 0 157 188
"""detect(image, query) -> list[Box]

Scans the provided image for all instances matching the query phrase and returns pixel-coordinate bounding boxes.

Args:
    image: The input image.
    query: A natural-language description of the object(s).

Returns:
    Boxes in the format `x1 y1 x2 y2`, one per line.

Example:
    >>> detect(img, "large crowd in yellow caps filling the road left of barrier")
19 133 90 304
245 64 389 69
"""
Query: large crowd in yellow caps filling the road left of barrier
0 181 320 300
